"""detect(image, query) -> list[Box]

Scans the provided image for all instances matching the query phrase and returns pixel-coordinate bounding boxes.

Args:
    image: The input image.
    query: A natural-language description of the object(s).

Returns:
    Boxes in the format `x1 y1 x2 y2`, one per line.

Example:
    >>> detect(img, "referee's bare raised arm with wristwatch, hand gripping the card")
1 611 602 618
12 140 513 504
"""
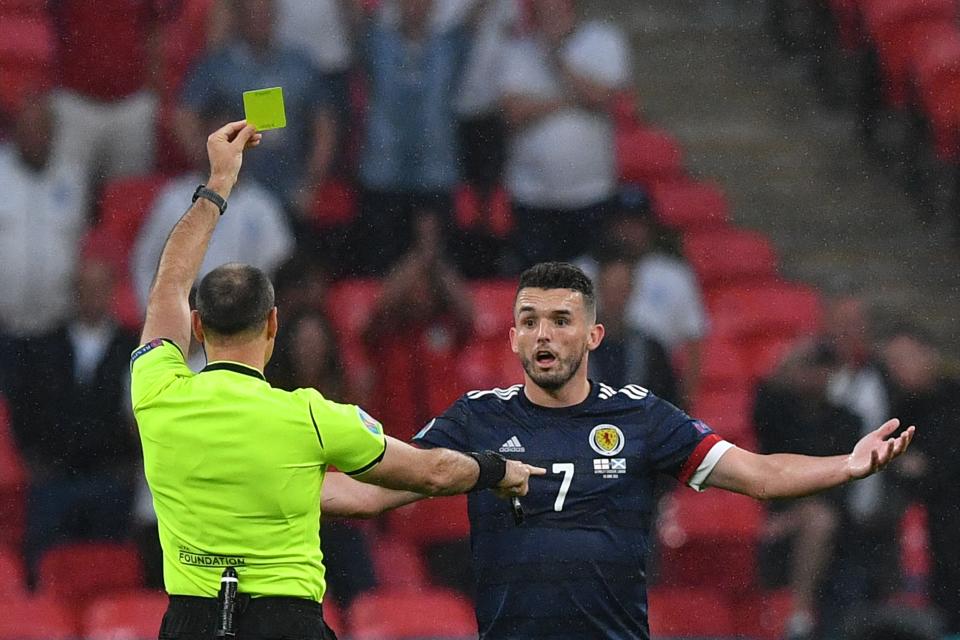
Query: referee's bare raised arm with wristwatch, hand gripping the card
140 120 261 353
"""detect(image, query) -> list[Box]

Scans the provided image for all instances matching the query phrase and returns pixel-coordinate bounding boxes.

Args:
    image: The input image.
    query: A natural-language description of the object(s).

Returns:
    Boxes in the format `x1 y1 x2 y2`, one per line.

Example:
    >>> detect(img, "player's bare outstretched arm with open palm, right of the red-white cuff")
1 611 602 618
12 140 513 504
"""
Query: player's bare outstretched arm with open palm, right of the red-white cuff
706 418 916 500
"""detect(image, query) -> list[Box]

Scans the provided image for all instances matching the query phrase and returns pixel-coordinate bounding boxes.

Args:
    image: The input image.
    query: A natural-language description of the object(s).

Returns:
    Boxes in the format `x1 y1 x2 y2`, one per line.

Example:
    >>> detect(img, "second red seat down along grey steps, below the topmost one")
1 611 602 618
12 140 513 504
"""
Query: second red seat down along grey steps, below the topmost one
650 180 730 232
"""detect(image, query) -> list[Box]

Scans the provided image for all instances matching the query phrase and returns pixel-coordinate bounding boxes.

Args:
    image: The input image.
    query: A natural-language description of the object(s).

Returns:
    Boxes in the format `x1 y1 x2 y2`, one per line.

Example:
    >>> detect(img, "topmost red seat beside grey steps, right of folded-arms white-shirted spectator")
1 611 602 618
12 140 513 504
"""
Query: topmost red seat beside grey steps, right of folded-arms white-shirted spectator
615 127 685 186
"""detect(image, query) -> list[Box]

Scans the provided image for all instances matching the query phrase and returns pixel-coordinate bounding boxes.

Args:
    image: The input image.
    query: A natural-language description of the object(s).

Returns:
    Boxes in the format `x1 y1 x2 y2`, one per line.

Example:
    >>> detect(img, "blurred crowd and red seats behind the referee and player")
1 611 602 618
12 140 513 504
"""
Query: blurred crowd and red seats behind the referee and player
0 0 960 639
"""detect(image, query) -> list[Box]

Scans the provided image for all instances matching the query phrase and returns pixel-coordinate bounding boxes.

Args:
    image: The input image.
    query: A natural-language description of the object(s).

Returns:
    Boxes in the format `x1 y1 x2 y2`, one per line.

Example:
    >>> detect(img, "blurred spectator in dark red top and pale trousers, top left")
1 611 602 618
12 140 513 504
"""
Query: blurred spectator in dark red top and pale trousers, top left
47 0 180 192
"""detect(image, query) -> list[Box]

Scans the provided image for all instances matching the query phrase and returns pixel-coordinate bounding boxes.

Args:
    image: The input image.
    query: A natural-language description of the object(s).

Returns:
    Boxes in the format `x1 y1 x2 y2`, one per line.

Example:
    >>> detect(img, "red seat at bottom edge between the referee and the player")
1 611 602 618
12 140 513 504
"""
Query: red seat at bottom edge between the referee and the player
347 589 477 640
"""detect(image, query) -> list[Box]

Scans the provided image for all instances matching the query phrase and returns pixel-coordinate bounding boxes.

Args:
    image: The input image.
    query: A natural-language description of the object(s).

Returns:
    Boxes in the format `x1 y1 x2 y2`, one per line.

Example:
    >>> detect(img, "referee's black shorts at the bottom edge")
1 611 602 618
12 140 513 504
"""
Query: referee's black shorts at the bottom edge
160 594 337 640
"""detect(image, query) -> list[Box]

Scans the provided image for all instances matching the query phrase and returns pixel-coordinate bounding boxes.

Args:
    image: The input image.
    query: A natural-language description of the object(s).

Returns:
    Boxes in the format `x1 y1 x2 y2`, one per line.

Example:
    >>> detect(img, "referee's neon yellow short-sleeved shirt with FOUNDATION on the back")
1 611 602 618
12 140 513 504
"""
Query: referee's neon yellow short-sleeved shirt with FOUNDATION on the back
130 339 386 602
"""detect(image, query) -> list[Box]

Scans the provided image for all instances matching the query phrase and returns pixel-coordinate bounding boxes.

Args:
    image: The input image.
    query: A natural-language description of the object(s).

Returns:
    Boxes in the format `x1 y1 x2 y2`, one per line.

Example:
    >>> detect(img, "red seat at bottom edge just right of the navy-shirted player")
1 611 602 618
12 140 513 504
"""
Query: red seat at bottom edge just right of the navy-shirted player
647 587 738 638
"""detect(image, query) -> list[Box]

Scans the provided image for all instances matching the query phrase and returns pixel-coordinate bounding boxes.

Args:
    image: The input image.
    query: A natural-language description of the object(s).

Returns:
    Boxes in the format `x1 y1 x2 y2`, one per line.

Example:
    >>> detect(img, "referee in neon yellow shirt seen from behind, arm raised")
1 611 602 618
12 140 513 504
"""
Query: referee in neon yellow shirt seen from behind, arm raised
131 121 544 640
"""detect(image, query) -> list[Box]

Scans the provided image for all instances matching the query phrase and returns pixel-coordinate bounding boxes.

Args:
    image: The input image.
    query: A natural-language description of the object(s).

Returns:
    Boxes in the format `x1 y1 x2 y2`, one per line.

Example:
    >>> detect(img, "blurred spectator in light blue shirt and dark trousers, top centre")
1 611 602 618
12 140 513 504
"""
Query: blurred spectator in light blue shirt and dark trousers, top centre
348 0 471 275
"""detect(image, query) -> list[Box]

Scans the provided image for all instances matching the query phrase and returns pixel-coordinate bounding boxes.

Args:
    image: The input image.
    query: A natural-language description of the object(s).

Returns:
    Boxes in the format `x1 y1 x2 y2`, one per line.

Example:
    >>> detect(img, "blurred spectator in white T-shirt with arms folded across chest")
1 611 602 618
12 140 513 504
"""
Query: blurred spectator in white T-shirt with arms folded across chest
500 0 630 270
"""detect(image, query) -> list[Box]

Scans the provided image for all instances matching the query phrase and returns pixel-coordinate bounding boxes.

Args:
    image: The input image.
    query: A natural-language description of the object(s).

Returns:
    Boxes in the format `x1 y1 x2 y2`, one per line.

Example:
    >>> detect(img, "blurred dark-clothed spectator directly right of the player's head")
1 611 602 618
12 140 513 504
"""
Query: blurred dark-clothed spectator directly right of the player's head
590 259 679 404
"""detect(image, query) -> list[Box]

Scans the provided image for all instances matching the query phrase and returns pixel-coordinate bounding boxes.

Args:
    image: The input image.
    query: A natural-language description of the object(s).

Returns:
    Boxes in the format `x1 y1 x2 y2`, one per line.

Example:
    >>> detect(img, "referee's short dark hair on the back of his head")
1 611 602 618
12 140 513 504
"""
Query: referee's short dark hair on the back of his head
197 262 274 337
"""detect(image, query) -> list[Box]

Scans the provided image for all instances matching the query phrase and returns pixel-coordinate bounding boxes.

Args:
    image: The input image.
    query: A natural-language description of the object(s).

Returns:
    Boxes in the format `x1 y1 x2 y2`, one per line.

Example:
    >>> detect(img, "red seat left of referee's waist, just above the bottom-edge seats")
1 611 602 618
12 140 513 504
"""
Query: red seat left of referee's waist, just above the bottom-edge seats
37 542 143 607
